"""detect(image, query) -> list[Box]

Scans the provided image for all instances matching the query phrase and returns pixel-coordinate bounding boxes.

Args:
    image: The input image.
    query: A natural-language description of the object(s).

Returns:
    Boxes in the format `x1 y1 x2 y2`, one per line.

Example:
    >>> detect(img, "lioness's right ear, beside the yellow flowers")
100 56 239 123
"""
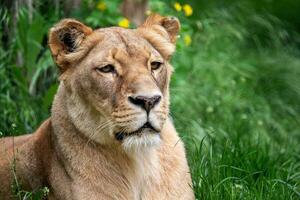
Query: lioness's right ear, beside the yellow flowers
138 14 180 59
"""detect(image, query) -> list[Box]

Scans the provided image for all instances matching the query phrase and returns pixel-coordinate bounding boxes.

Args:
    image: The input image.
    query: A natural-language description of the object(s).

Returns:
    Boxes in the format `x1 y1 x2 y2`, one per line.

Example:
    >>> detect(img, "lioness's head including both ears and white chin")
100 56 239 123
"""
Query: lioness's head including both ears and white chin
49 15 180 152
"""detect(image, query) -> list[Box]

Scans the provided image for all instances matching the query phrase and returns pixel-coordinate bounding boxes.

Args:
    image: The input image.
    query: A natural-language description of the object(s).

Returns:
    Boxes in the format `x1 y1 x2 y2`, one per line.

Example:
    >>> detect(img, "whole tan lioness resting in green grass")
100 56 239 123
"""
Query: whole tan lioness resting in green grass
0 15 194 200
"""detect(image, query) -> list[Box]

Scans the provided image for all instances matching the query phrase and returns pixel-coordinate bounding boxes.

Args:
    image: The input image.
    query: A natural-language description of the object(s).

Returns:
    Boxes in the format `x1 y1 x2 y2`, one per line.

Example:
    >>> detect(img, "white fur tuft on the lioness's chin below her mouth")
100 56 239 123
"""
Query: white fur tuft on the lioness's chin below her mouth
122 133 161 154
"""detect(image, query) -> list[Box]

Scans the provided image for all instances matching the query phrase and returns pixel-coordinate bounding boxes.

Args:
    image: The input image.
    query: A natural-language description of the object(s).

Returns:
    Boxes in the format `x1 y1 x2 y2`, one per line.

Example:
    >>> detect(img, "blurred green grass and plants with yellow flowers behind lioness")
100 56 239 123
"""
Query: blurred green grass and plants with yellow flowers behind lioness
0 0 300 200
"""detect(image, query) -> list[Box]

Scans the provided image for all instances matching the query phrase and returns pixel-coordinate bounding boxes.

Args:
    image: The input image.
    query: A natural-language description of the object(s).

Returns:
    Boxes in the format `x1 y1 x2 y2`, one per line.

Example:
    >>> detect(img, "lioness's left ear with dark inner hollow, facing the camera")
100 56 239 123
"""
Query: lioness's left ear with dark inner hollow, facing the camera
49 19 93 72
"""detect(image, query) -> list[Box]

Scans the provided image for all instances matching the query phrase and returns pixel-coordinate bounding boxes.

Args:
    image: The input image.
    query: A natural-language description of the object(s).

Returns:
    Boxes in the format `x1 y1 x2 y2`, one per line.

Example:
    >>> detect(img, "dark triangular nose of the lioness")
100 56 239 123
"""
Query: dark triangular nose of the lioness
128 95 161 113
